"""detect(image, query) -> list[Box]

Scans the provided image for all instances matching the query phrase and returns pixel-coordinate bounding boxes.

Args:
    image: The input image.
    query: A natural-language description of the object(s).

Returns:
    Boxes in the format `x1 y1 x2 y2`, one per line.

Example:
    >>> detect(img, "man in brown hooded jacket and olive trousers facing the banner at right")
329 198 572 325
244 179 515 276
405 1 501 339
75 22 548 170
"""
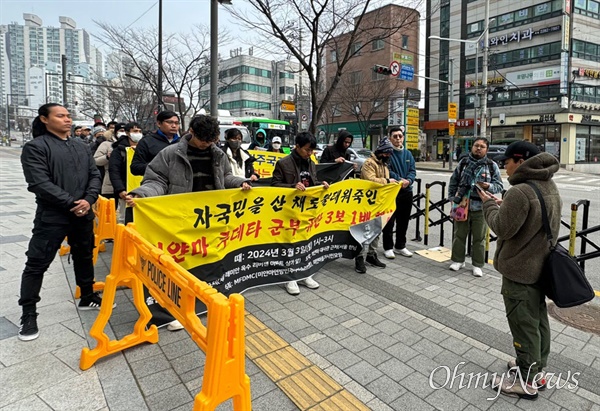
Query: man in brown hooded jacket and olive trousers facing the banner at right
479 141 562 400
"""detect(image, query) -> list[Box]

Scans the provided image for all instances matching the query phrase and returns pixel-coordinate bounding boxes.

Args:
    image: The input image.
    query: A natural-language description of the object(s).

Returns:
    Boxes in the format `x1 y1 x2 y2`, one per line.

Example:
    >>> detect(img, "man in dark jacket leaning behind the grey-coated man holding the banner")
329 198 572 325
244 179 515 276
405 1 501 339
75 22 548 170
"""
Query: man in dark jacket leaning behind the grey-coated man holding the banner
131 111 179 176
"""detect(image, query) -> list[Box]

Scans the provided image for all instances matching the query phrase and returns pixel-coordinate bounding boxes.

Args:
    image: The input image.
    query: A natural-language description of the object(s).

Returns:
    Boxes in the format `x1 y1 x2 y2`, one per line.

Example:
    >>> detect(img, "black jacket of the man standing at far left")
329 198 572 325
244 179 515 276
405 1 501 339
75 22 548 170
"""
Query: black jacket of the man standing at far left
21 133 102 222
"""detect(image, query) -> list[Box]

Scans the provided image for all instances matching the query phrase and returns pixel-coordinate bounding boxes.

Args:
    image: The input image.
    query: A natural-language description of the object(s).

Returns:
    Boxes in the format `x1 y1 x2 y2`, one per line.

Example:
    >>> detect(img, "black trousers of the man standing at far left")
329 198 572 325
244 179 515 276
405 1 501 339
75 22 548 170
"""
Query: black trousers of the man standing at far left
19 211 94 313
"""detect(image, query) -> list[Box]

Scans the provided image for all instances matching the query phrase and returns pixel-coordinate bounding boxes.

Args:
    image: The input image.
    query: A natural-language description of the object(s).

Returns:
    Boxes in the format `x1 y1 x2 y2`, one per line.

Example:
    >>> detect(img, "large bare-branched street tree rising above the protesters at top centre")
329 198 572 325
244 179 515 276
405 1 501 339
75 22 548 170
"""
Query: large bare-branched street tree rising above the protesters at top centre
229 0 422 133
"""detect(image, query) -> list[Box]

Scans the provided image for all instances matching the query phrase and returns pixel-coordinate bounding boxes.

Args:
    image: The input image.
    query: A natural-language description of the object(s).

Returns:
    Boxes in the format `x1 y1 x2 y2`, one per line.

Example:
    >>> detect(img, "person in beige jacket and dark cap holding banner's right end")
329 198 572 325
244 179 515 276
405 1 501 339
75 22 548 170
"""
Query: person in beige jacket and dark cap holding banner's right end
354 138 398 274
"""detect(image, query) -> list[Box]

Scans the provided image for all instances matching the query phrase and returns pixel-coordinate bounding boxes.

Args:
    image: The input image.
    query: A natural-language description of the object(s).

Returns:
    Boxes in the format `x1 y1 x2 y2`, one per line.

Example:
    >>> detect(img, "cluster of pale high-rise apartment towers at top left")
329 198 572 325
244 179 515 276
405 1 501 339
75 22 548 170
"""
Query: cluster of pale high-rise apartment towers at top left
0 13 104 118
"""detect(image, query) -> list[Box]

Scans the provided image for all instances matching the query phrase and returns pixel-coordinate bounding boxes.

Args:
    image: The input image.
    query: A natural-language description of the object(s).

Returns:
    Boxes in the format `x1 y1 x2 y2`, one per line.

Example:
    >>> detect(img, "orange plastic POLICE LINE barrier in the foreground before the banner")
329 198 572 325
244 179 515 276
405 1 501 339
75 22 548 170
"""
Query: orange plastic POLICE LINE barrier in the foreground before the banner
79 224 251 411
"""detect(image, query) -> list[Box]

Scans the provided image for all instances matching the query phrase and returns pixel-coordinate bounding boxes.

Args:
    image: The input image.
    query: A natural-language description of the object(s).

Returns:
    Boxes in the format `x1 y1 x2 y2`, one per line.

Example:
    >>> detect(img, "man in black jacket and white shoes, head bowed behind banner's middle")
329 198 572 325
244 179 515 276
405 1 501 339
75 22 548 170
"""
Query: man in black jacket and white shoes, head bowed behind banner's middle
271 131 329 295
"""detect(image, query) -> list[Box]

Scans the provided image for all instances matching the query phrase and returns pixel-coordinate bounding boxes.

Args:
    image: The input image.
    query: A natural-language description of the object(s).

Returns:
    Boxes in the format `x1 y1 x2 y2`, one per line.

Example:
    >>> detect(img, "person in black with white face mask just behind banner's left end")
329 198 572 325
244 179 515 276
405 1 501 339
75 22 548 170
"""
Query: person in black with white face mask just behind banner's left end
108 123 144 224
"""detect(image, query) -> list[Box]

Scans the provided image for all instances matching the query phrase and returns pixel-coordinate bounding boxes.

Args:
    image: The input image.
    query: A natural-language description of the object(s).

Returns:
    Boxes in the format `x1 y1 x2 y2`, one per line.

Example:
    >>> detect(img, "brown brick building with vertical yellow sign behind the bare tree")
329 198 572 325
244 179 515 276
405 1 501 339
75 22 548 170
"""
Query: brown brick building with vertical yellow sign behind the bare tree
318 4 420 149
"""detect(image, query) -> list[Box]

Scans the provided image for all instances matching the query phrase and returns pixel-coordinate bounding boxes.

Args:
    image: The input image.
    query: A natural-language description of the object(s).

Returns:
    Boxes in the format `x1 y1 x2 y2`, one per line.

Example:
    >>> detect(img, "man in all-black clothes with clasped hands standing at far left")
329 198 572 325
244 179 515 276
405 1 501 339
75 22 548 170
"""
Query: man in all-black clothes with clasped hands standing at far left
18 103 102 341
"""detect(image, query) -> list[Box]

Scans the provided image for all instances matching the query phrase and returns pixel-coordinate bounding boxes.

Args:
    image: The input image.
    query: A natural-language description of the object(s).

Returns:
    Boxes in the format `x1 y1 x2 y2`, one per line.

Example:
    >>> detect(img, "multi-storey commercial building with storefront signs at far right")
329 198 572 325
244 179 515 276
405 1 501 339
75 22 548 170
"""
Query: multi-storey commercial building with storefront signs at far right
424 0 600 173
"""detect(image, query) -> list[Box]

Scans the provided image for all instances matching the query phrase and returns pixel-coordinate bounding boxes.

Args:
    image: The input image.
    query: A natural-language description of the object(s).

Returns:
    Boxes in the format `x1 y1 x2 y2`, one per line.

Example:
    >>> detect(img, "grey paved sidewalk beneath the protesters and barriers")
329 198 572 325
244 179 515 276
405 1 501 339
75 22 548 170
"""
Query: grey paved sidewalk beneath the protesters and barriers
0 147 600 411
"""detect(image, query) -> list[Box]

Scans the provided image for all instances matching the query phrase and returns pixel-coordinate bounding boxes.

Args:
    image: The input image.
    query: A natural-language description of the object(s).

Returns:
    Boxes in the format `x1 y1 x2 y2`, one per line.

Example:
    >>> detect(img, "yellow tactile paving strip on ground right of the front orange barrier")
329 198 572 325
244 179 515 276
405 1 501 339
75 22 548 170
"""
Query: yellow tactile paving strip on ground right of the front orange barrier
246 313 369 411
